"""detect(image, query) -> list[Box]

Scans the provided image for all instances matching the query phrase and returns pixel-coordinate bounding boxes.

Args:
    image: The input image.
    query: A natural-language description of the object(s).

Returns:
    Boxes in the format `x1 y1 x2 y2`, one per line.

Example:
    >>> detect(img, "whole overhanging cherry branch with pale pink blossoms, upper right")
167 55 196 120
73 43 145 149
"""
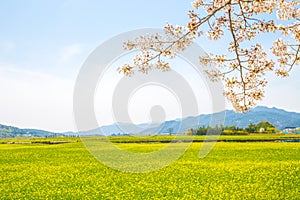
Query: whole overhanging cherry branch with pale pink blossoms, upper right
118 0 300 112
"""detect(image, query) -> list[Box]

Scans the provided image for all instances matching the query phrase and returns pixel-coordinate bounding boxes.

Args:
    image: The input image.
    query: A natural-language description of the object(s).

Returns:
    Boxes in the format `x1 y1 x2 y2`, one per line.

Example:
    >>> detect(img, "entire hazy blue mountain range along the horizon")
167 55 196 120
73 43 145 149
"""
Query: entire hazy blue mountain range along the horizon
0 106 300 138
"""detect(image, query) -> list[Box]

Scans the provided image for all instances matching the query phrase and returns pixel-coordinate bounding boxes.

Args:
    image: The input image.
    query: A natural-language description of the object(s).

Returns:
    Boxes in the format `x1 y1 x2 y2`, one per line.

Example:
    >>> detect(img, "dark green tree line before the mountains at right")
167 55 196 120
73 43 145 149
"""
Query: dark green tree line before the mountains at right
186 122 279 135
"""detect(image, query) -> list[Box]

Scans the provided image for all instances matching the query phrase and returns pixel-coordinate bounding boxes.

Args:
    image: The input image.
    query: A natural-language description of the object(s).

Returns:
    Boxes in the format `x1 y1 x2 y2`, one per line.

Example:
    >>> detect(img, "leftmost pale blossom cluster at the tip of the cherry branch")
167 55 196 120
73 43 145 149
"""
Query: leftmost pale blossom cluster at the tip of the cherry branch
118 24 196 76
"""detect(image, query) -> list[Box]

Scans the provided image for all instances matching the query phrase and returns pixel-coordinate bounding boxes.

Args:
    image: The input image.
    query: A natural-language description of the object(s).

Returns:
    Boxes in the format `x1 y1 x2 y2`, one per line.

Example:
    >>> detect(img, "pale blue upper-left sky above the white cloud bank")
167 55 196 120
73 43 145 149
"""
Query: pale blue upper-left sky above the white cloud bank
0 0 190 75
